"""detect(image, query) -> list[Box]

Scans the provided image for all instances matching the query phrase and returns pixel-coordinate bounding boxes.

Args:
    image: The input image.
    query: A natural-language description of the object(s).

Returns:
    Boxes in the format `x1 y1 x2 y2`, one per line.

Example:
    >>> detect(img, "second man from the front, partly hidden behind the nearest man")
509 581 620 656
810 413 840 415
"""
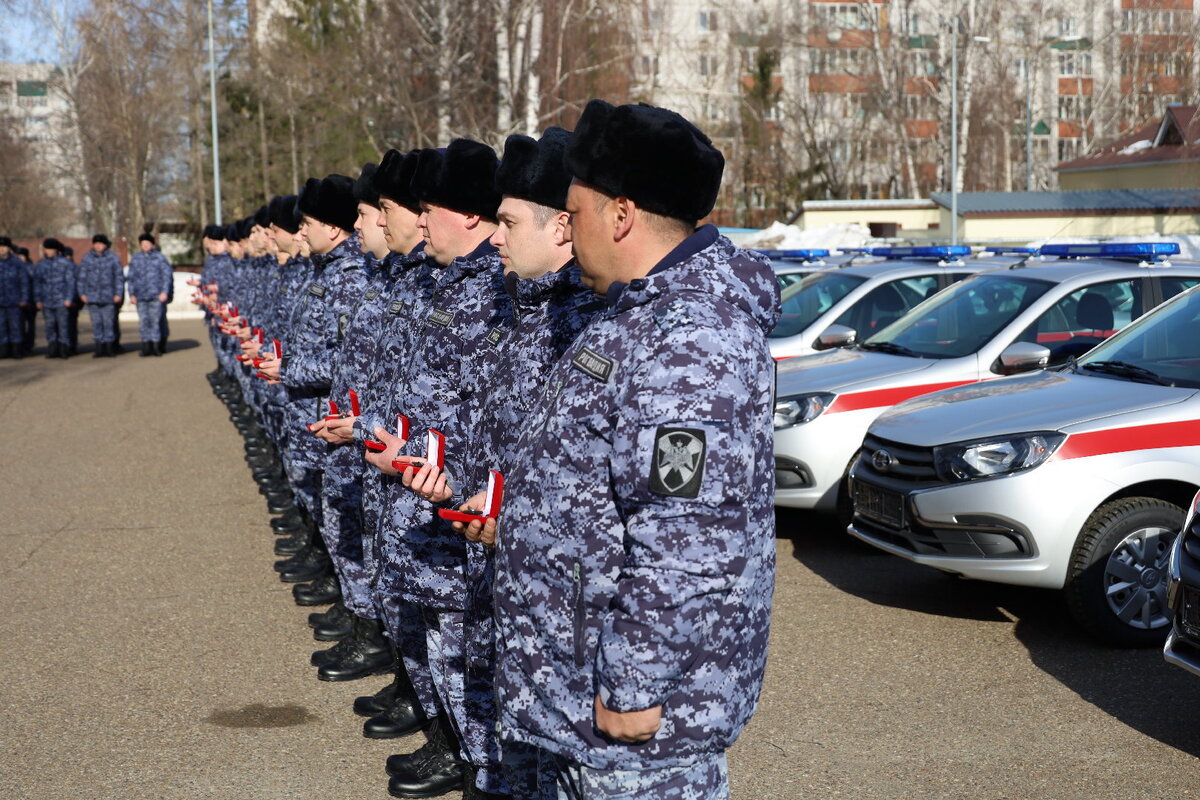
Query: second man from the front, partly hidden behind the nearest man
404 128 602 796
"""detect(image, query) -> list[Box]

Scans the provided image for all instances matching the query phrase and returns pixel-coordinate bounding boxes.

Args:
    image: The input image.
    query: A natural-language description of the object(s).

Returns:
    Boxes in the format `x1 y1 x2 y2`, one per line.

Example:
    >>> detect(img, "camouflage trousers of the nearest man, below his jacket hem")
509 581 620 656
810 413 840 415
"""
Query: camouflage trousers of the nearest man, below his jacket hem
538 751 730 800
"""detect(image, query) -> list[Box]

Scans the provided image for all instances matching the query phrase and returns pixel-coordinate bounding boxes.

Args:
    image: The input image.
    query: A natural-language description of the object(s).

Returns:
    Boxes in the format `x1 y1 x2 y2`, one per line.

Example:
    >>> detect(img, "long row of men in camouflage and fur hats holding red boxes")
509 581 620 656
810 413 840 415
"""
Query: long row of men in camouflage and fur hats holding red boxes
198 101 779 800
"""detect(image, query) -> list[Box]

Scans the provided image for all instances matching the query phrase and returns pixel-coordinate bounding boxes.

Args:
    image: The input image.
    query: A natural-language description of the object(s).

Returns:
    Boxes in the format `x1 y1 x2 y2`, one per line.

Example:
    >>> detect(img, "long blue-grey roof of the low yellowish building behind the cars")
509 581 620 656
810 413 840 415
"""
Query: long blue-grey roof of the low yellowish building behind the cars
930 188 1200 215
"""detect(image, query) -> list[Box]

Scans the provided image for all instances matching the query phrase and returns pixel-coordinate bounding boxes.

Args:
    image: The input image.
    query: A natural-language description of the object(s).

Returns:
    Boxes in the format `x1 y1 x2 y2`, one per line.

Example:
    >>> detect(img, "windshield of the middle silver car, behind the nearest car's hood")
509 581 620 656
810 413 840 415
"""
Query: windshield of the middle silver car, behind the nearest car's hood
862 275 1052 359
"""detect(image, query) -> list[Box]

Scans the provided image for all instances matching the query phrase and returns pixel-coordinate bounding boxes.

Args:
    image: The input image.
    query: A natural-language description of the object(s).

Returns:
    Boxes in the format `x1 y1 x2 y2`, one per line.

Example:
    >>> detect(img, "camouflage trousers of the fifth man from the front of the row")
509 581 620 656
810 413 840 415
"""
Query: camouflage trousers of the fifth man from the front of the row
322 460 377 618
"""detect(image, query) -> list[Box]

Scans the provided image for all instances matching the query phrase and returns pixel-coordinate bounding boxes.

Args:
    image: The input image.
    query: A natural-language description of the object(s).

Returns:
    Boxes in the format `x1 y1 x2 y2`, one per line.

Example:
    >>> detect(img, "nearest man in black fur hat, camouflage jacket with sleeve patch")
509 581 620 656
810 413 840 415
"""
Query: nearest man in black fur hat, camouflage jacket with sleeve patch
476 101 779 800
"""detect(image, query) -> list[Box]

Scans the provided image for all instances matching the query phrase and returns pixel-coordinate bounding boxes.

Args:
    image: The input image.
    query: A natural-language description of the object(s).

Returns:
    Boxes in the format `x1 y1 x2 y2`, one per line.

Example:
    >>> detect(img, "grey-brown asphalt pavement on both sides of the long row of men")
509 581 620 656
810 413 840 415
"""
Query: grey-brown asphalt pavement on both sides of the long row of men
0 318 1200 800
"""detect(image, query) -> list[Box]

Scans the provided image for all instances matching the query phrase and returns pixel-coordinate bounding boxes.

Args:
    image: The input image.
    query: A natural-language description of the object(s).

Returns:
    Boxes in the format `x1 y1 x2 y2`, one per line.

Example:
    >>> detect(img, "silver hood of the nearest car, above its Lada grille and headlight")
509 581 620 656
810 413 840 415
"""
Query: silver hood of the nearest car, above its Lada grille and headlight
871 372 1195 446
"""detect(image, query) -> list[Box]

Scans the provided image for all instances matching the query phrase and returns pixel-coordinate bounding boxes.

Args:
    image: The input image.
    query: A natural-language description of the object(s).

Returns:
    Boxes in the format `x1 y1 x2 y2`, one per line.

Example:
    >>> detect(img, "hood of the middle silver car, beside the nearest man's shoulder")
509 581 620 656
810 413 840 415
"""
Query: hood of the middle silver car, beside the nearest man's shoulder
775 348 942 397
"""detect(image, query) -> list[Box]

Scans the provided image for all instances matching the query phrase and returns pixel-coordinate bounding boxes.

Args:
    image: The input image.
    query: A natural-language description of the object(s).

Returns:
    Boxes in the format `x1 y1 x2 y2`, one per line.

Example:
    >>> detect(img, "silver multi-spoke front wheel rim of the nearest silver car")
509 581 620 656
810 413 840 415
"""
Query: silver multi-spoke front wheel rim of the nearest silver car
1104 528 1175 631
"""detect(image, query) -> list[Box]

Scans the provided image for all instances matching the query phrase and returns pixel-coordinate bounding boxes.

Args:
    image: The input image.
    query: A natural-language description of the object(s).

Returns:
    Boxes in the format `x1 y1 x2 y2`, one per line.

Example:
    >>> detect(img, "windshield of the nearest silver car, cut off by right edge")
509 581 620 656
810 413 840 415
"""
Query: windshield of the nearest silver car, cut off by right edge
1076 289 1200 389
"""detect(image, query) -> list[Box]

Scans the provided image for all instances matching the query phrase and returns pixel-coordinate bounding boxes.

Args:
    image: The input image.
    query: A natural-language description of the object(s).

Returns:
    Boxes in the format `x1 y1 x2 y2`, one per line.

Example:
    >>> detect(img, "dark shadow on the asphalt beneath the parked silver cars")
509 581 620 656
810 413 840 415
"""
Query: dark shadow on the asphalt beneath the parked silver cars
776 509 1200 757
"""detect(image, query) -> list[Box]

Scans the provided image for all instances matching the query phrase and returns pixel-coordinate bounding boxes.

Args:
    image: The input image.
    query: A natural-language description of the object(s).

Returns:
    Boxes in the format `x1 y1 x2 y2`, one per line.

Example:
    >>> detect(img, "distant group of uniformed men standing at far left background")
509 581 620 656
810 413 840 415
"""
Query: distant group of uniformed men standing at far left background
0 234 174 359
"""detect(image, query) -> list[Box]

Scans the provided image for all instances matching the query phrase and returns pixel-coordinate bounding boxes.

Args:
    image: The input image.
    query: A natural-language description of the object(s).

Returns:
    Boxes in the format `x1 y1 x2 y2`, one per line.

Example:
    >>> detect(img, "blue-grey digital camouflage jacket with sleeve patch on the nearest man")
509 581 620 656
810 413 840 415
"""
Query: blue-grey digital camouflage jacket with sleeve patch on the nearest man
494 225 779 770
